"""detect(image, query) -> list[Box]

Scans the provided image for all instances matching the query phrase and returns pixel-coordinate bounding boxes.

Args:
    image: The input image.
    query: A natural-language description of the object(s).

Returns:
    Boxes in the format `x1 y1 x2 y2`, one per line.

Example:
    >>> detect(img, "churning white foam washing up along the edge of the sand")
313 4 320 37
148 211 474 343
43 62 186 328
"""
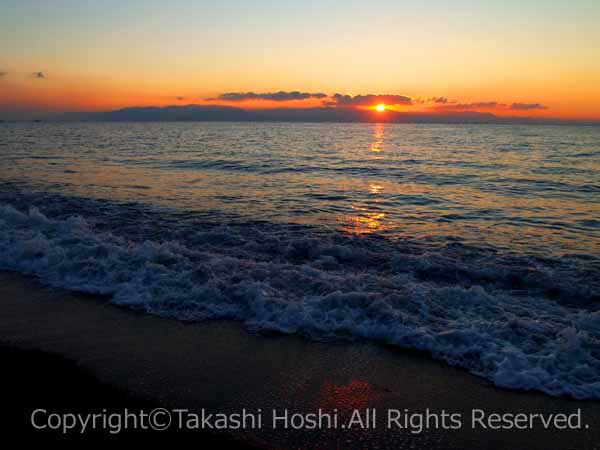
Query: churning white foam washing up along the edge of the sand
0 202 600 399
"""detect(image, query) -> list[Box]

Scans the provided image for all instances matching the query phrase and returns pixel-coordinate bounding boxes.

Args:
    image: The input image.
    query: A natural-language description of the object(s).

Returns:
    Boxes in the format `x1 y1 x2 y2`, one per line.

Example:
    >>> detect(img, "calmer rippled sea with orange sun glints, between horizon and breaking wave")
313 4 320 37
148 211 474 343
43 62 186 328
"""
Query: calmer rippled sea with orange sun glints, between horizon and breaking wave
0 123 600 255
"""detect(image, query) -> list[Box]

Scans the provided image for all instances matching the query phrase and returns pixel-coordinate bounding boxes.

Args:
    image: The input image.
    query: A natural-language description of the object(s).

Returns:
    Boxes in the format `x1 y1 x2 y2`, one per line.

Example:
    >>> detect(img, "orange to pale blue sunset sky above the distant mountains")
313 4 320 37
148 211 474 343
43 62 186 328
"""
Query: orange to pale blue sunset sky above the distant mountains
0 0 600 120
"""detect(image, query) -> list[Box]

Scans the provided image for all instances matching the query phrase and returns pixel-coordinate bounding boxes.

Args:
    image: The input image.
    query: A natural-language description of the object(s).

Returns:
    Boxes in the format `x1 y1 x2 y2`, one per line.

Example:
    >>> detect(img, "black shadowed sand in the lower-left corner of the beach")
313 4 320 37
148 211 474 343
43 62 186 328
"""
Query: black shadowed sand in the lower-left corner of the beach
0 345 259 450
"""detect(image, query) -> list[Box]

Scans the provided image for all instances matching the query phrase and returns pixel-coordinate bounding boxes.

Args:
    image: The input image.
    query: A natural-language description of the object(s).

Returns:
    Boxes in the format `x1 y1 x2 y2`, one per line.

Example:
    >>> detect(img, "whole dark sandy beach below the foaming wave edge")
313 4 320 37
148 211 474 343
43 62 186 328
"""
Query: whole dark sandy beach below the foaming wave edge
0 273 600 450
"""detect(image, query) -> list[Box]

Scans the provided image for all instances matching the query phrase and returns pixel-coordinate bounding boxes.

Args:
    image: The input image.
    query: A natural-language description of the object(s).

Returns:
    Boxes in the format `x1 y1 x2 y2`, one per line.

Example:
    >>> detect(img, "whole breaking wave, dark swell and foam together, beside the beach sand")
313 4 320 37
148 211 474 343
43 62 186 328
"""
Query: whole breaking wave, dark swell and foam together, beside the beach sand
0 201 600 399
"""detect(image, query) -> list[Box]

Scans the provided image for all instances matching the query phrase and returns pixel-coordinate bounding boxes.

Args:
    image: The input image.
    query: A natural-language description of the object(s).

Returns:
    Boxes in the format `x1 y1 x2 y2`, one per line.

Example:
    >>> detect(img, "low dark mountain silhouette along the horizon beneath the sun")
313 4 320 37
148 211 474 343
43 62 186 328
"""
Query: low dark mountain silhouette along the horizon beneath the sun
50 105 600 125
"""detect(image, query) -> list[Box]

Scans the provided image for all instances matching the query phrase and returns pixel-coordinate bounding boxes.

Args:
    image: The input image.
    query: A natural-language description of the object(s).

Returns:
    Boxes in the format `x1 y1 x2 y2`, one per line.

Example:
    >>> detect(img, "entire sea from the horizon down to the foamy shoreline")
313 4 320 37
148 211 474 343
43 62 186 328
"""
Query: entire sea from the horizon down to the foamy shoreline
0 122 600 399
